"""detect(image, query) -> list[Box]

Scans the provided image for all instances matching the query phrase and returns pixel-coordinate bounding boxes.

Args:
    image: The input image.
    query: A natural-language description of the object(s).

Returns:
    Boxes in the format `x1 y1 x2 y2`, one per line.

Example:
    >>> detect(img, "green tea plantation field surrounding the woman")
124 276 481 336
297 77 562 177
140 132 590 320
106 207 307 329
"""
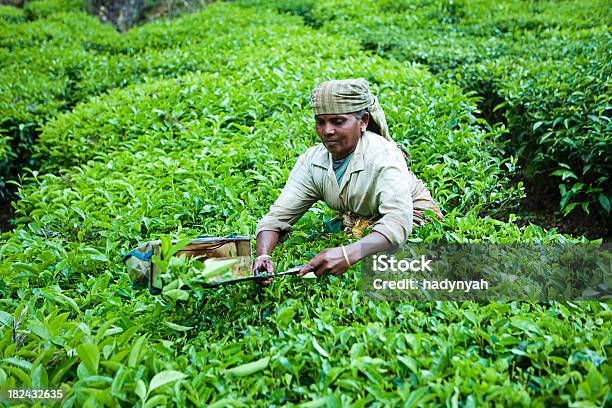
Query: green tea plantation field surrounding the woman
0 0 612 407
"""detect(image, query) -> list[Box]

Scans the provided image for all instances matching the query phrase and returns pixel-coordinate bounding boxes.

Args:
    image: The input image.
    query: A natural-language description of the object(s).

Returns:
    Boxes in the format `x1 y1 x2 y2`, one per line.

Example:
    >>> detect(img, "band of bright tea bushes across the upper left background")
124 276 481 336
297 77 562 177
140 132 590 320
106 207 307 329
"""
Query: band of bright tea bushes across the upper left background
0 3 340 197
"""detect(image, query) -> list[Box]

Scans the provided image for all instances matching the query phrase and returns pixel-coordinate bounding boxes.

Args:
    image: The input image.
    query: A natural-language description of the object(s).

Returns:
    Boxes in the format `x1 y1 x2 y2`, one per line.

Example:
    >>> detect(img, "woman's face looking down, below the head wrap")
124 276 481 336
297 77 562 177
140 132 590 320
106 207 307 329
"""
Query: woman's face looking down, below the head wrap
315 113 368 160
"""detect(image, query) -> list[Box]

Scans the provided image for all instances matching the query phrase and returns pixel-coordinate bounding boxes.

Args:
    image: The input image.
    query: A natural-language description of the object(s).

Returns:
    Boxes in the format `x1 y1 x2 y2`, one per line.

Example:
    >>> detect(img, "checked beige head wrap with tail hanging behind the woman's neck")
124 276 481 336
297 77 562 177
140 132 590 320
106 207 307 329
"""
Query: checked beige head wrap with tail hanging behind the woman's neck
310 78 393 141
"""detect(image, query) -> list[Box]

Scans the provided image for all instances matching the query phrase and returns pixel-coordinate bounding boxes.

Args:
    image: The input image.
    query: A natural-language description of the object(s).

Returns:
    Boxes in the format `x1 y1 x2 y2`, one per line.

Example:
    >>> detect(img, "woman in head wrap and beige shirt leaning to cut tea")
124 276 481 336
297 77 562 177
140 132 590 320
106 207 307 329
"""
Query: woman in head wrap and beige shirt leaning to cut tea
253 78 441 283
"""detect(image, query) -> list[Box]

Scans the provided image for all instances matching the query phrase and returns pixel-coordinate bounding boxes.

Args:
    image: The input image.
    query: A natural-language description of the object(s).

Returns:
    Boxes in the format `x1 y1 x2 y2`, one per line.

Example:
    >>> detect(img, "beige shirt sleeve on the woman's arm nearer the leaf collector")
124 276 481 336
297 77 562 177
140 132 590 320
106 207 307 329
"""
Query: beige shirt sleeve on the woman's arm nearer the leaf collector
255 154 319 242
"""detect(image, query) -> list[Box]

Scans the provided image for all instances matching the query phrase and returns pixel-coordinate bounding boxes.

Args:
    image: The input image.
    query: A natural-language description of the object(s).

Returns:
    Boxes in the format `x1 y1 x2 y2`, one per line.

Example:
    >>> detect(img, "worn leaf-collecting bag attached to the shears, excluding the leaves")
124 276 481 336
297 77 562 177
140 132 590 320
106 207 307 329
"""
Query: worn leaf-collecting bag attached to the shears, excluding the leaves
123 234 251 295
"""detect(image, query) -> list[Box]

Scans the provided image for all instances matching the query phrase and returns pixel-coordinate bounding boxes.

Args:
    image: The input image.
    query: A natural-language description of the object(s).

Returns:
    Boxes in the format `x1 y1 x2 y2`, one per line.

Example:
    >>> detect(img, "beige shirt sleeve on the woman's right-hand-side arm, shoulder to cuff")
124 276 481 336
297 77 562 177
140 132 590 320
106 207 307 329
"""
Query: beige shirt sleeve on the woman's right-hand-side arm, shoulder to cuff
372 147 414 248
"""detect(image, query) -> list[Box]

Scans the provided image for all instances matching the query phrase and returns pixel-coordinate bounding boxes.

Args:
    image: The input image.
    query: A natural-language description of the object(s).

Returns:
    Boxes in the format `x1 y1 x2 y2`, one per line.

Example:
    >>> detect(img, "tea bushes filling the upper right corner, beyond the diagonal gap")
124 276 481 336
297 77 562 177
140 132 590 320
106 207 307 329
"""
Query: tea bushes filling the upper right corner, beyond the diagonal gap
247 0 612 214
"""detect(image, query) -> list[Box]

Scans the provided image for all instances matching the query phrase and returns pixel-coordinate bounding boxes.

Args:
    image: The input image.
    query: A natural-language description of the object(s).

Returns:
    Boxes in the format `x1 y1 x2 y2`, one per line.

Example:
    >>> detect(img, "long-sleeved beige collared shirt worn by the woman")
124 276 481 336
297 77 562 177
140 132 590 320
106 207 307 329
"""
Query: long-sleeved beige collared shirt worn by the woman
255 131 426 246
